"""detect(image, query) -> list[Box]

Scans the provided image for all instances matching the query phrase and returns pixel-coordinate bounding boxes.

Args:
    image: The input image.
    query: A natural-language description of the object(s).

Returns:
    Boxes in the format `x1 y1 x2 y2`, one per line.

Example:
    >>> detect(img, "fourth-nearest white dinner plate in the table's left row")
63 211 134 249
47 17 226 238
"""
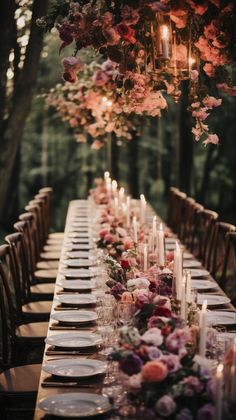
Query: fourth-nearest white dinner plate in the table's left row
51 310 98 324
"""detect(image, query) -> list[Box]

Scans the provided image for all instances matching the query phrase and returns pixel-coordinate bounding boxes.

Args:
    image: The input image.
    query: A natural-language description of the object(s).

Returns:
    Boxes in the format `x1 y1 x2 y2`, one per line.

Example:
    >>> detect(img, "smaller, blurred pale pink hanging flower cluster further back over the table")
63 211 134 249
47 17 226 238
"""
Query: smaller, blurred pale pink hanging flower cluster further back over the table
43 57 167 149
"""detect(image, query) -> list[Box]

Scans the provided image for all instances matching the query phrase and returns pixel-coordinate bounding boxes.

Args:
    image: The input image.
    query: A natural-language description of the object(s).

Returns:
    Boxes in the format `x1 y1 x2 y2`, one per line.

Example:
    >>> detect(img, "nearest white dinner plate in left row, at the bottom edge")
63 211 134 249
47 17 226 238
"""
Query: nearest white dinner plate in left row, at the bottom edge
38 392 111 418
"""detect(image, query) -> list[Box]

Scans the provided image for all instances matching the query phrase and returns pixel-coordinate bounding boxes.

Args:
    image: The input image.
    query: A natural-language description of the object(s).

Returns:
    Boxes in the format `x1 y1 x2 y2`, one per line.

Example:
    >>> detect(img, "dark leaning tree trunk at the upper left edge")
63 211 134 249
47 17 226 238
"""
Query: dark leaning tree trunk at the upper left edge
0 0 48 223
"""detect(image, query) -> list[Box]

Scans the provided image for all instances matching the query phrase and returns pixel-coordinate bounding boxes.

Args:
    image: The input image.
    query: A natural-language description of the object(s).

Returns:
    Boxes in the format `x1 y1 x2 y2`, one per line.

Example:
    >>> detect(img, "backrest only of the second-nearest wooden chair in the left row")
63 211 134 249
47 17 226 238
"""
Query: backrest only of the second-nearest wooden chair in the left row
5 232 31 310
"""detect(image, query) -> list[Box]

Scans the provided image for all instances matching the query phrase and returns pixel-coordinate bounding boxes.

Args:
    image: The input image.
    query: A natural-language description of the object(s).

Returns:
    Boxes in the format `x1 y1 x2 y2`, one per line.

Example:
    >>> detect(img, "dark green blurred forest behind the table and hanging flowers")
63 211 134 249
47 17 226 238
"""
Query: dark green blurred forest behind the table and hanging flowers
0 0 236 238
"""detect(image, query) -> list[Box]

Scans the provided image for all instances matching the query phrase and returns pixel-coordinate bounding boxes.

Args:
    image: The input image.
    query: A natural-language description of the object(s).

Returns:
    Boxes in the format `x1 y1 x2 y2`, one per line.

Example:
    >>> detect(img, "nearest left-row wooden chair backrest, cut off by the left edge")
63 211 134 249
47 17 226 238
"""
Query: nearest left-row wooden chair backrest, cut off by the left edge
0 245 17 368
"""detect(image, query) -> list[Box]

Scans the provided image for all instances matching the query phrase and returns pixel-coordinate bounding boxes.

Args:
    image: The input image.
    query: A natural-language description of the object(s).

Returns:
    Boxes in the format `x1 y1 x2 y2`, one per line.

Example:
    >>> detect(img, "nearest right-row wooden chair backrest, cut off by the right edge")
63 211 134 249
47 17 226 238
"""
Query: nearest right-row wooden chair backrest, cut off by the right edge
219 232 236 306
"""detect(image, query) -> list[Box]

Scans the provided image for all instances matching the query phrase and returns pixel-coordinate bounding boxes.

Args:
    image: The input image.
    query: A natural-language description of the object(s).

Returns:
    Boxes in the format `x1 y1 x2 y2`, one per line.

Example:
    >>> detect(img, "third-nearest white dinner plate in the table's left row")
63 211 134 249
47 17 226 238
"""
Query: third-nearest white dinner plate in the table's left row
45 331 102 348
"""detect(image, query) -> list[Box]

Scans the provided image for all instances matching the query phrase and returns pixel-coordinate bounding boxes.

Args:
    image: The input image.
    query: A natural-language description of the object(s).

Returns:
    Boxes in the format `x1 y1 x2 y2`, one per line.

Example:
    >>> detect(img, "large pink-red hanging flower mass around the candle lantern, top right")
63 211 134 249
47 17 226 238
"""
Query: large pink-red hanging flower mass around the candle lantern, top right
39 0 236 144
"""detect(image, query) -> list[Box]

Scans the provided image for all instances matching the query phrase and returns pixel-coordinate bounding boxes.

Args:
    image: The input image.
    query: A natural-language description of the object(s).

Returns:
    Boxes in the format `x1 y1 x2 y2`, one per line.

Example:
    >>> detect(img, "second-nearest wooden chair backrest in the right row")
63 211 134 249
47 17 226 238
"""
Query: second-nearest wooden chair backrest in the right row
209 222 236 282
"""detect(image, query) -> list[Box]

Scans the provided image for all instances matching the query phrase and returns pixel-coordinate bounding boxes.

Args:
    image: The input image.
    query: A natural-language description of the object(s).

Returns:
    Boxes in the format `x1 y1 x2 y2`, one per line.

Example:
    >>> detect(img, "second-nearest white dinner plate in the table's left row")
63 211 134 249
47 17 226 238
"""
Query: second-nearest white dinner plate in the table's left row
42 359 107 378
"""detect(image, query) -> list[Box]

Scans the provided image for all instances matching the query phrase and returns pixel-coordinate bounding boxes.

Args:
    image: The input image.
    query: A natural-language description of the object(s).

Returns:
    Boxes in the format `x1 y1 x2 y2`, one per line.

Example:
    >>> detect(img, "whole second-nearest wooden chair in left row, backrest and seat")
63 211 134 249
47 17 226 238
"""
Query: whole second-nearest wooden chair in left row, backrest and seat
5 232 51 322
